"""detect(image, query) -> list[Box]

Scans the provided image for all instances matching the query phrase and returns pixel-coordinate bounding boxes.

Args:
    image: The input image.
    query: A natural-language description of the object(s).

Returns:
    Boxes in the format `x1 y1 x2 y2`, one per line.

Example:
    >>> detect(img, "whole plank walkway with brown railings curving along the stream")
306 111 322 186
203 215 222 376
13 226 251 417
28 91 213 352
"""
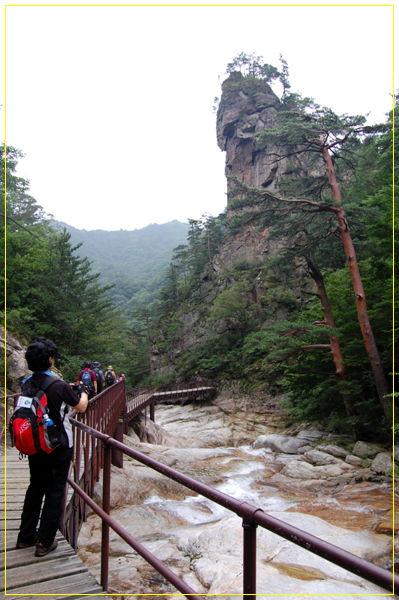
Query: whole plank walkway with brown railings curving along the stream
0 381 399 600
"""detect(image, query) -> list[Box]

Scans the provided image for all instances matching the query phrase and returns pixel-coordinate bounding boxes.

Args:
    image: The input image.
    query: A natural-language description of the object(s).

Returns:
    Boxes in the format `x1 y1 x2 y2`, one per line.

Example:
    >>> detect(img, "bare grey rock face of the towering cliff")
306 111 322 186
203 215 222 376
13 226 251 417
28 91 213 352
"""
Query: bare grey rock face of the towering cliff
151 73 309 375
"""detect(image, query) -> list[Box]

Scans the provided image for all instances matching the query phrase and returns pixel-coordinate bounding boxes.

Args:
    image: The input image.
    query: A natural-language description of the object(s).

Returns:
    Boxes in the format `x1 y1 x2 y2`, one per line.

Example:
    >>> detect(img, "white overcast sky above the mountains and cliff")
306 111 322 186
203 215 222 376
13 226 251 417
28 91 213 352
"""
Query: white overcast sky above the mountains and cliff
2 5 398 230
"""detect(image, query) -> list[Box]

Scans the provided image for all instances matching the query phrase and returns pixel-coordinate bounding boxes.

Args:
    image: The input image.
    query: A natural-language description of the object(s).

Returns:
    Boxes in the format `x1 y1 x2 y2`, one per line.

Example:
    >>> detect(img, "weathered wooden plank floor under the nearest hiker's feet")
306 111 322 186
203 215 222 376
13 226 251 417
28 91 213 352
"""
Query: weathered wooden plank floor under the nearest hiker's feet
0 448 104 600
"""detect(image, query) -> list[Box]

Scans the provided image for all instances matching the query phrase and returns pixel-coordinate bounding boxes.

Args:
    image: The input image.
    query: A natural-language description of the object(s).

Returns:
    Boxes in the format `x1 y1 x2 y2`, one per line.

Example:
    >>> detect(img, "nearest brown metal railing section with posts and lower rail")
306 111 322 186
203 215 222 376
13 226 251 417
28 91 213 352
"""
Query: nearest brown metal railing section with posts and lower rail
68 419 399 600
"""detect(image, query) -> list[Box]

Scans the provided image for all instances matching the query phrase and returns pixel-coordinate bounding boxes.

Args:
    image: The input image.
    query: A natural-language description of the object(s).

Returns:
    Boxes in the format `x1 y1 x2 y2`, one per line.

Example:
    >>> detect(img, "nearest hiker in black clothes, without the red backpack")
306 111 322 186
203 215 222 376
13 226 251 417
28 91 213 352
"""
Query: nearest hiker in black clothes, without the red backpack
16 337 88 556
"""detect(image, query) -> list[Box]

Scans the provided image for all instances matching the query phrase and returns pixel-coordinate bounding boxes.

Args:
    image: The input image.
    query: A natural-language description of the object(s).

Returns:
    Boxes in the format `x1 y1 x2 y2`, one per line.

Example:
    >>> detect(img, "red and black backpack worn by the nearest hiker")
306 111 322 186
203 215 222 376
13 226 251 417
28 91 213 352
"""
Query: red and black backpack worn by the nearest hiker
9 377 61 454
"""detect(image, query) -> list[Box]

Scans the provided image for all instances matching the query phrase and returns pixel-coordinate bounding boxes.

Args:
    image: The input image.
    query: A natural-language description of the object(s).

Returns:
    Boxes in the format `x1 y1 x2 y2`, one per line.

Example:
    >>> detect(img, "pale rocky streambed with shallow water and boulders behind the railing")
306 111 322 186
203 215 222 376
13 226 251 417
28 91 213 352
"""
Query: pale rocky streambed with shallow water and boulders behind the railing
79 394 393 599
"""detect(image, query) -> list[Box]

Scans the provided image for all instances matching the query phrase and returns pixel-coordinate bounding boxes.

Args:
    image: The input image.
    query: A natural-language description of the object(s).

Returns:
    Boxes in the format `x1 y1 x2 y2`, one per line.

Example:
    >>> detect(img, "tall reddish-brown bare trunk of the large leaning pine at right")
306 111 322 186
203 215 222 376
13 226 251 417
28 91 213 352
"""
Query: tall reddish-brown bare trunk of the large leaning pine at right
321 146 393 423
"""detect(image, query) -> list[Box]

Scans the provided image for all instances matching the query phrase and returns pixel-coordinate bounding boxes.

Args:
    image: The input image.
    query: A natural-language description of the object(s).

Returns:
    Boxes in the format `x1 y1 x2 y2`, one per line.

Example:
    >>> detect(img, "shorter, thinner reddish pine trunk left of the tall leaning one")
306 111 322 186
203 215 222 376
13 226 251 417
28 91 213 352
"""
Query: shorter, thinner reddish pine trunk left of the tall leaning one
305 256 355 417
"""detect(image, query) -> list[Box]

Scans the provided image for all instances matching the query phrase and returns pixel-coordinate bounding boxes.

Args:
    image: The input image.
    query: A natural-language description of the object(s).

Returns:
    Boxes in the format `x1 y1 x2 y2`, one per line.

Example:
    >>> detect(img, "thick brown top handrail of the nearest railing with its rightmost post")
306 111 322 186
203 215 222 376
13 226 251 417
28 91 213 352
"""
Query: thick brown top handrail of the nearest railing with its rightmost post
69 419 399 597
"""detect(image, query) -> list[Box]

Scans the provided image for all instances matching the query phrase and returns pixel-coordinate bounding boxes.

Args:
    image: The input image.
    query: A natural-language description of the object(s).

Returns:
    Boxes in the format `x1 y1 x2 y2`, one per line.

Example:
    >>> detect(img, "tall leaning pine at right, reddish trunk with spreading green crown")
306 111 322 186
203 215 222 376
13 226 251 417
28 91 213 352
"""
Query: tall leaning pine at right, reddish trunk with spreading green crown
230 82 393 422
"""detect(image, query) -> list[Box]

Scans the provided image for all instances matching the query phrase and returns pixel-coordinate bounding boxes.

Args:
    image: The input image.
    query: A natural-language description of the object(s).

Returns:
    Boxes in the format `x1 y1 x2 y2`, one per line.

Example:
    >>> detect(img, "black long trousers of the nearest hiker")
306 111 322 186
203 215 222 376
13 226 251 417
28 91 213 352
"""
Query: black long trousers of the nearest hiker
18 446 72 547
